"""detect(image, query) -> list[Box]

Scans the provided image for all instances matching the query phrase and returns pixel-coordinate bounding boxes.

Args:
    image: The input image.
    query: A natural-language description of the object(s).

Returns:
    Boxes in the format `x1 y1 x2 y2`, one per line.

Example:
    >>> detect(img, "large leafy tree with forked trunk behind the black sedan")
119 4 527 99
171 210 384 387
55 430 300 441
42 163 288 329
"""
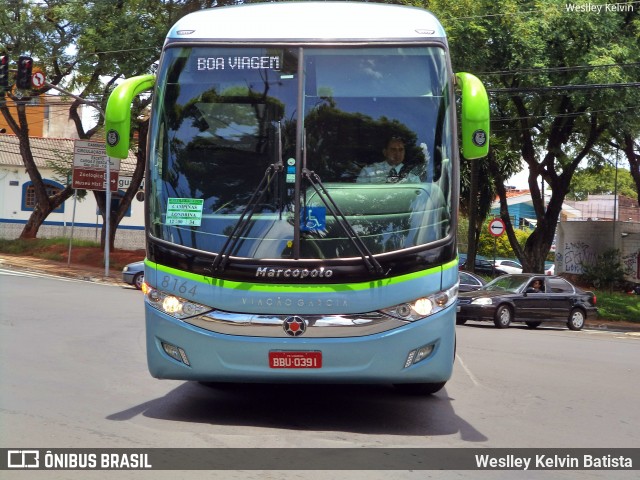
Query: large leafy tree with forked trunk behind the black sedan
427 0 640 272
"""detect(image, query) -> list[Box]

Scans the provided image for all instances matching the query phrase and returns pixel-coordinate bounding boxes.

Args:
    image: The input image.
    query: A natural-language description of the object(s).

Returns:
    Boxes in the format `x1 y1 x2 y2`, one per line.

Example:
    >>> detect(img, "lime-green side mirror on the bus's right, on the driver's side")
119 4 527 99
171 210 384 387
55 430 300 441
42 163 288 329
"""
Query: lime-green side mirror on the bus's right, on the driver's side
456 72 490 160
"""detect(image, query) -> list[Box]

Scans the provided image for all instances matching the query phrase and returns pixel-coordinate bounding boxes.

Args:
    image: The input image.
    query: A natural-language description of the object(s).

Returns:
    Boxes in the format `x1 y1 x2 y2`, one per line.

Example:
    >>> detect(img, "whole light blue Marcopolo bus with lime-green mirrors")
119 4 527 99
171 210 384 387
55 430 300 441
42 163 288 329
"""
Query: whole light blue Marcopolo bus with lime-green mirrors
105 2 489 394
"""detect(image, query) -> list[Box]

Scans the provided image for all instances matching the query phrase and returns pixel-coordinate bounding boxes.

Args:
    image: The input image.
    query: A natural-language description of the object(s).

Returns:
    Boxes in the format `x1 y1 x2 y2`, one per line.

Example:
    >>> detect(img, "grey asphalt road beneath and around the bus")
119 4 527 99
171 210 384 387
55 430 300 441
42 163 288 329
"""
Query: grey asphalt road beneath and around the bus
0 271 640 480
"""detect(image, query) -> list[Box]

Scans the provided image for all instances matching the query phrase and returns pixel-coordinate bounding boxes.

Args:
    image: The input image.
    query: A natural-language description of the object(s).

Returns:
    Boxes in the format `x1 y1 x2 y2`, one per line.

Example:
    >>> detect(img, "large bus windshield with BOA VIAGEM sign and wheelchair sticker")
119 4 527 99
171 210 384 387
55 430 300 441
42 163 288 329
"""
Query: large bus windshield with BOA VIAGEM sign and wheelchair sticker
148 46 455 259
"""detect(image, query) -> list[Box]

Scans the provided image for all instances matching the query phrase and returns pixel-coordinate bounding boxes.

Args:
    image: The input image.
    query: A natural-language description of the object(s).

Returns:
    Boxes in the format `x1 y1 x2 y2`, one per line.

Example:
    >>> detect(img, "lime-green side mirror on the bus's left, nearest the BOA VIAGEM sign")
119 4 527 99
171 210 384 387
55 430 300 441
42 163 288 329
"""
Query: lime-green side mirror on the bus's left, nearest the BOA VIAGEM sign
104 75 156 158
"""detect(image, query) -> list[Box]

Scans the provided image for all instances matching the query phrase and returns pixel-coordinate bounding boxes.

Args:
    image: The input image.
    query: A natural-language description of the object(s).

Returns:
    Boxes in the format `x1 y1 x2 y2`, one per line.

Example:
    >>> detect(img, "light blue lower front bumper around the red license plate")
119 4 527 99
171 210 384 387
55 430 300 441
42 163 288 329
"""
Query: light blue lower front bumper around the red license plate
145 304 455 383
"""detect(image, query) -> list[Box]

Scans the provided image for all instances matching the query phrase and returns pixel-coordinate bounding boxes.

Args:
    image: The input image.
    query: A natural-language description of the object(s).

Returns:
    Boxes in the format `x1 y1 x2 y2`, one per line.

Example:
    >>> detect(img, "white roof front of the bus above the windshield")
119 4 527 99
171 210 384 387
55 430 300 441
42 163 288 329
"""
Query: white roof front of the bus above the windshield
167 2 445 43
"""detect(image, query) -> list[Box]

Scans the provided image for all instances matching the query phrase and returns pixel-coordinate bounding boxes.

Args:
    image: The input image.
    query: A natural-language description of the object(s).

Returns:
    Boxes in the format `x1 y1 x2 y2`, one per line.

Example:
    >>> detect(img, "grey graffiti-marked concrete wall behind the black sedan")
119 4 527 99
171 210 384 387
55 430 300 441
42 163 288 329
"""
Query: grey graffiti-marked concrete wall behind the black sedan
556 221 640 283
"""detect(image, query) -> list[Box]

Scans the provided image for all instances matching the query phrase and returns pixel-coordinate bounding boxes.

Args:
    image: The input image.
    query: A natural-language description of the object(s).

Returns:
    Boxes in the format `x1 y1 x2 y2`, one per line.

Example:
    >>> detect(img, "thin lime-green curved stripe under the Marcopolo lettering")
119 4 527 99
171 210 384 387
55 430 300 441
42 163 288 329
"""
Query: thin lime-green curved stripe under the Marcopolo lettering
145 259 458 293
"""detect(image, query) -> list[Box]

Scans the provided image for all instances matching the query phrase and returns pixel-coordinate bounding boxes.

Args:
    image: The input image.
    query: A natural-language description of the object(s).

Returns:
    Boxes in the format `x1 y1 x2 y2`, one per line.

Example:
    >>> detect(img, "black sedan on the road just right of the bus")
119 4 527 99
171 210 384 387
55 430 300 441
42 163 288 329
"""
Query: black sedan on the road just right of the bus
456 273 597 330
